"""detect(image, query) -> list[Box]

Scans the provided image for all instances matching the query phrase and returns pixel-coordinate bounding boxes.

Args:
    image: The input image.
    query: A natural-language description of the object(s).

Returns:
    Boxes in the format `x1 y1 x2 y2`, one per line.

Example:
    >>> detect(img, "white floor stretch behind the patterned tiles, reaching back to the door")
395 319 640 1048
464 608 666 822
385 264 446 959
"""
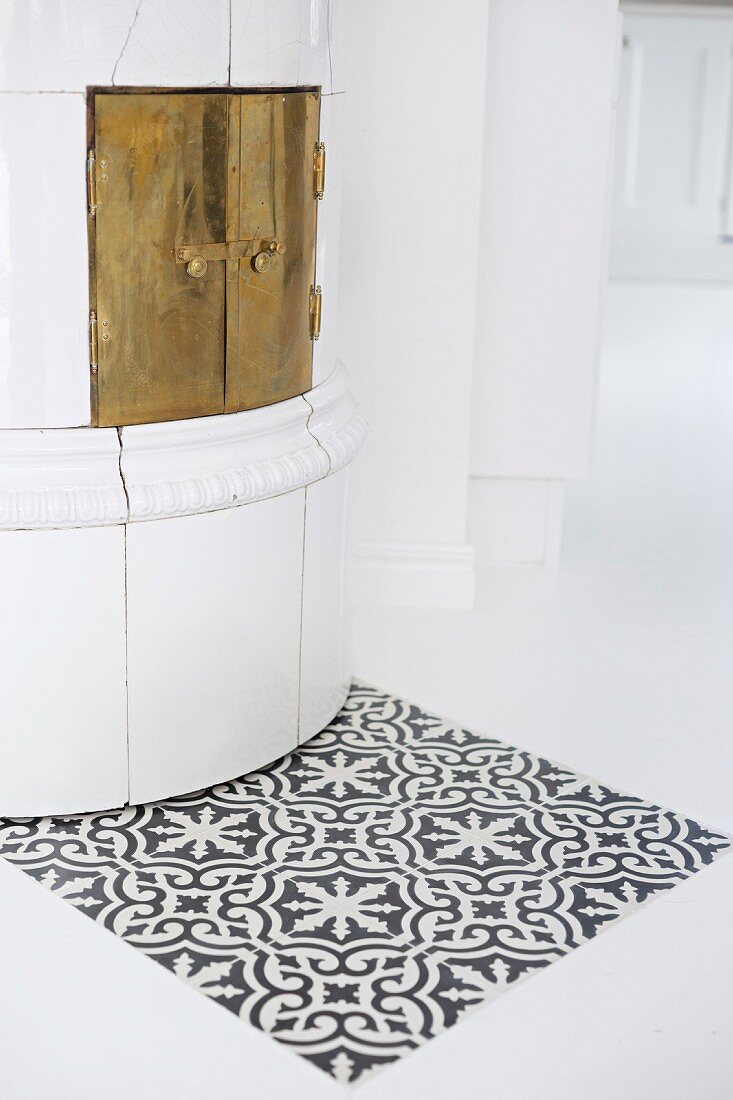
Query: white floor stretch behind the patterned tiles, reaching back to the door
355 284 733 831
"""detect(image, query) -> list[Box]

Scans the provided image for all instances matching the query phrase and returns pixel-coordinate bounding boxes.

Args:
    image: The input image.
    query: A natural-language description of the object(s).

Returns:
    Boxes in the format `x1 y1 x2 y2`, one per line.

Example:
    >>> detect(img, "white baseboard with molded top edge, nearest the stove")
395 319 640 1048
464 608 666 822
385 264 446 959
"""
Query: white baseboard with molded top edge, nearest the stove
351 542 475 609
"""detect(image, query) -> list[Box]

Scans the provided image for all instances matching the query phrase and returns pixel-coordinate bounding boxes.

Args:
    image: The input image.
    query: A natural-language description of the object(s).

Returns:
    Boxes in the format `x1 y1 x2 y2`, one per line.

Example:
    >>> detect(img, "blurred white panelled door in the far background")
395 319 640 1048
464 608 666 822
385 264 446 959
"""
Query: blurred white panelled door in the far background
612 11 733 278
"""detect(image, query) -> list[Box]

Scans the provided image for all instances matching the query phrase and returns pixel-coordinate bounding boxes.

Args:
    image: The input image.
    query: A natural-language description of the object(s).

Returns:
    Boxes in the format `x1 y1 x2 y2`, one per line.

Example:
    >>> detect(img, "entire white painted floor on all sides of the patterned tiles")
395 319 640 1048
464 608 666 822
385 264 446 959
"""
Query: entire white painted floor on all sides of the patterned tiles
0 286 733 1100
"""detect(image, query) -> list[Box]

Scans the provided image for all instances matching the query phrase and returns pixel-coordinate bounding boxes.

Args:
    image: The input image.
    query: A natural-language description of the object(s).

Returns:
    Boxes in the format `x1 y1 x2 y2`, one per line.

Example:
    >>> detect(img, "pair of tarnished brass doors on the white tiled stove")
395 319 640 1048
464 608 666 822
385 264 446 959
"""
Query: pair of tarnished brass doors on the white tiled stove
89 89 320 426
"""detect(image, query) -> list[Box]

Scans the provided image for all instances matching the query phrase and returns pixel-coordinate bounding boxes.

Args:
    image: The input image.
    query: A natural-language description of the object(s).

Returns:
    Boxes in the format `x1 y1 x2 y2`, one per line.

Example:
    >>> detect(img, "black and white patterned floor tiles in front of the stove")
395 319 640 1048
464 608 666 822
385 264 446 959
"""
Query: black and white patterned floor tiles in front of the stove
0 686 731 1081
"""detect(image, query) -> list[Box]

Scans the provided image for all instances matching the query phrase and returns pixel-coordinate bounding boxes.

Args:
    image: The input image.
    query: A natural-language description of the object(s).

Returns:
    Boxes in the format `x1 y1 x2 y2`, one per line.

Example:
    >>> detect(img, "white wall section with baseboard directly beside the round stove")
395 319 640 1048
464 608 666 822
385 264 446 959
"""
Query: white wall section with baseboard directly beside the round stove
339 0 488 605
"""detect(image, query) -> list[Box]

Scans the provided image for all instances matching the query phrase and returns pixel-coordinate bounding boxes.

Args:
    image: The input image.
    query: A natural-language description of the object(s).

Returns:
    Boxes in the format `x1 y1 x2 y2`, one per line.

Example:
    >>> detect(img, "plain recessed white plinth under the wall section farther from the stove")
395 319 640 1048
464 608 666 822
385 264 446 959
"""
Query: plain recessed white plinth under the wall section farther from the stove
468 477 565 565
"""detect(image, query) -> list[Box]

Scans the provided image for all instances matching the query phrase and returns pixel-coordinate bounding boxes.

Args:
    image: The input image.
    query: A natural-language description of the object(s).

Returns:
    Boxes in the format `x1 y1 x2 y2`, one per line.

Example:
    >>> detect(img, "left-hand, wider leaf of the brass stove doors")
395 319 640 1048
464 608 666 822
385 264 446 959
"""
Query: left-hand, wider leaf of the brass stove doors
92 92 228 426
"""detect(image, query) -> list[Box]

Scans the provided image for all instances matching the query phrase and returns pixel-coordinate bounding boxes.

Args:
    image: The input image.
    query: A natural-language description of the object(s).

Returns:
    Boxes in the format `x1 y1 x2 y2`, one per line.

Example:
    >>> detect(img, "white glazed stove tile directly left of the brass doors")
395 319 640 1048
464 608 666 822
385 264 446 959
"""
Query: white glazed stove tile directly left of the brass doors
0 95 89 428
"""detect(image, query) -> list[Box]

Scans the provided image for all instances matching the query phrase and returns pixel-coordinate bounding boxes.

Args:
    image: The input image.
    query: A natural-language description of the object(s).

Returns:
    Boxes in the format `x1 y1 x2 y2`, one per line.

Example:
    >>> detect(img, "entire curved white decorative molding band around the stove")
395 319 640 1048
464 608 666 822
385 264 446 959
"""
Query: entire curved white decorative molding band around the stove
0 366 365 530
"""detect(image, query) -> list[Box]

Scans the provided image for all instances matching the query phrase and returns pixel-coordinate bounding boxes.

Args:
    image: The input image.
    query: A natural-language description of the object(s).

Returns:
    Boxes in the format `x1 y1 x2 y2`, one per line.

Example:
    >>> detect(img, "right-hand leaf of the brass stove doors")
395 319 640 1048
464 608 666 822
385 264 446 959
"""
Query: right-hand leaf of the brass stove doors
226 91 320 413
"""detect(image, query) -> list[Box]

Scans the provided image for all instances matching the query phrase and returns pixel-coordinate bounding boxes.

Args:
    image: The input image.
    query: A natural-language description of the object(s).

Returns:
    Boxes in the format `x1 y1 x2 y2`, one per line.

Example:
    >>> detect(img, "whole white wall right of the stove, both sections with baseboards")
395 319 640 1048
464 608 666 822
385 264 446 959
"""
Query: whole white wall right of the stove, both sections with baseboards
339 0 619 606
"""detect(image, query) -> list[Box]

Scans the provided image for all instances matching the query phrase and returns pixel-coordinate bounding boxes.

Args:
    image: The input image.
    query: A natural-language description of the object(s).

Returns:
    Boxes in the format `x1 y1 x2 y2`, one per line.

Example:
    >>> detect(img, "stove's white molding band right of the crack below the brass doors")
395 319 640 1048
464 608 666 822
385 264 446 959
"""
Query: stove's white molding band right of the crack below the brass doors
122 367 365 523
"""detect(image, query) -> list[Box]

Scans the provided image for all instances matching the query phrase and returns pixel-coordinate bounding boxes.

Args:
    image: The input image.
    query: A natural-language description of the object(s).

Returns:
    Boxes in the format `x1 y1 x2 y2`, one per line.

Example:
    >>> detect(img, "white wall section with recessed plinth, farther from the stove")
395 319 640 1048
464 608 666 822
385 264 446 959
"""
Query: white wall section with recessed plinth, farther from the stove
469 0 619 563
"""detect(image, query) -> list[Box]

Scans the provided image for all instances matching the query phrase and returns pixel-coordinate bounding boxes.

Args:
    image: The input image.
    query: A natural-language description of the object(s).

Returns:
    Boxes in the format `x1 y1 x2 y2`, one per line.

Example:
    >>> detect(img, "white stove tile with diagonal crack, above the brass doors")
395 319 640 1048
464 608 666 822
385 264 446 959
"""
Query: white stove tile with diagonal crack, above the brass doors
0 0 229 91
